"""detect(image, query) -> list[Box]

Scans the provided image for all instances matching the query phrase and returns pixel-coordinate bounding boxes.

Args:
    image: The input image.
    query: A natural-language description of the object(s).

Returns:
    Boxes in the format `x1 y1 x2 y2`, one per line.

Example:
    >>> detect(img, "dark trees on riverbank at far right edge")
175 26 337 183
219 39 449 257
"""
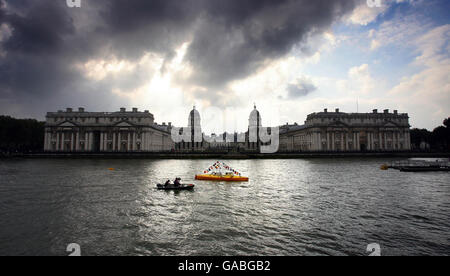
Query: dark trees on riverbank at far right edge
411 117 450 151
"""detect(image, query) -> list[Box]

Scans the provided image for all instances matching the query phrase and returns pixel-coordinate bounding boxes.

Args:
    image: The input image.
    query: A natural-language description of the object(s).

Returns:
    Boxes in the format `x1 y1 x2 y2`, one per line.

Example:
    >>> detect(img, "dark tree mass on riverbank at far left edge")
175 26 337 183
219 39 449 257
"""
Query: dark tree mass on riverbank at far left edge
0 116 45 153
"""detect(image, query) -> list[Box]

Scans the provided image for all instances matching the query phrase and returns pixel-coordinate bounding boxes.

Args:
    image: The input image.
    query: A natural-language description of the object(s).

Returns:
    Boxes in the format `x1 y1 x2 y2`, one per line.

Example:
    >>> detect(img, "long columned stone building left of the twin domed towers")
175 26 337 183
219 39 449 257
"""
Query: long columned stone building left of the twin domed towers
44 108 174 152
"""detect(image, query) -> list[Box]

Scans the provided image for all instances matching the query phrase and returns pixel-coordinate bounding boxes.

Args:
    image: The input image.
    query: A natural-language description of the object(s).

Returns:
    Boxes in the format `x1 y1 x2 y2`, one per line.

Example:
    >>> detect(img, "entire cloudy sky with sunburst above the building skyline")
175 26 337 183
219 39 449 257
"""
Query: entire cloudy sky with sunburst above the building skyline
0 0 450 132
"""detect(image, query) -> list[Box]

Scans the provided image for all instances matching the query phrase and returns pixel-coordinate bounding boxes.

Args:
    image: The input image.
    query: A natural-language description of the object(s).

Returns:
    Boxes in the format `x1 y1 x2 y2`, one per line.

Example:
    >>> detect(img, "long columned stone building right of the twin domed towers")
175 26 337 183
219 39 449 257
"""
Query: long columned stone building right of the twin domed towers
279 109 411 152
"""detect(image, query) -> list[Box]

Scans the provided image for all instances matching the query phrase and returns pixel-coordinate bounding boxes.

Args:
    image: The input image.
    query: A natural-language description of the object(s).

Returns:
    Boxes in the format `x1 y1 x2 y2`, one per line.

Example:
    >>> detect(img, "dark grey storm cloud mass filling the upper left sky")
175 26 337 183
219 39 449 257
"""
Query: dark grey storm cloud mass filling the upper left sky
0 0 356 117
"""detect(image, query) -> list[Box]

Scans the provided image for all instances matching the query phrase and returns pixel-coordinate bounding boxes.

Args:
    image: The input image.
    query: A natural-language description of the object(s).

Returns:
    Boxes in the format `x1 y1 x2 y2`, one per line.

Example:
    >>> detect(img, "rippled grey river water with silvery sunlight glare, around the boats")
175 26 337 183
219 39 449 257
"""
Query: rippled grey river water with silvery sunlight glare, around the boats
0 159 450 255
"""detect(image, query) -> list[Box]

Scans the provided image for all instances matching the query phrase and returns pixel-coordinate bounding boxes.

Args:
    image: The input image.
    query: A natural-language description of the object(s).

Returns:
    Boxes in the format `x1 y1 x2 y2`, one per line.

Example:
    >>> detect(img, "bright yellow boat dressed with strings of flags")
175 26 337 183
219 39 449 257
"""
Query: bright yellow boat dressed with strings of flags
195 161 249 182
